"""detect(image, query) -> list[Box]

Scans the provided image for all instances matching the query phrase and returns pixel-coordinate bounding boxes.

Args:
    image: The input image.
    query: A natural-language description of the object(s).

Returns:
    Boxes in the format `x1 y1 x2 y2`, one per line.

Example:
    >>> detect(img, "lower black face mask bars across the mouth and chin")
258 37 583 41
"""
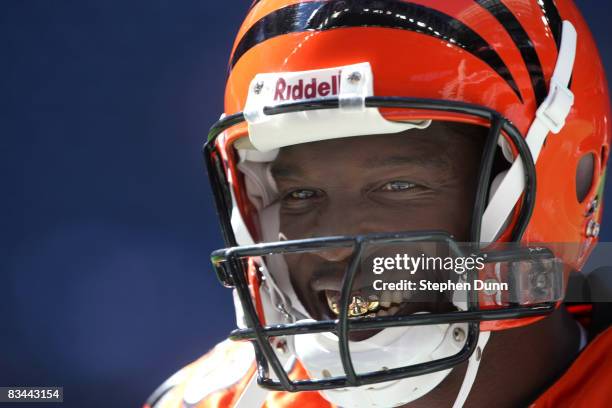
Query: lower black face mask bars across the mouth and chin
213 231 554 391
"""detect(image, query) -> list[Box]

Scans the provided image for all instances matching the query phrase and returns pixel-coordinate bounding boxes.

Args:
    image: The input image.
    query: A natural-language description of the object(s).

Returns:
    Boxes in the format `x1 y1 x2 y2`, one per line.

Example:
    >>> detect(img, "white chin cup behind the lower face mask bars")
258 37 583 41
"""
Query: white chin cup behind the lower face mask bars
295 323 468 408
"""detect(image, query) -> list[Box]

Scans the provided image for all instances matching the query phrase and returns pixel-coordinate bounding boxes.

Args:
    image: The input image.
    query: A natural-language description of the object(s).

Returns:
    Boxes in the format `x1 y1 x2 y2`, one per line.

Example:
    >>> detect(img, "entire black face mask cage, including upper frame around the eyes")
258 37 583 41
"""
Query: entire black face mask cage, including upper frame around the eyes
203 97 544 392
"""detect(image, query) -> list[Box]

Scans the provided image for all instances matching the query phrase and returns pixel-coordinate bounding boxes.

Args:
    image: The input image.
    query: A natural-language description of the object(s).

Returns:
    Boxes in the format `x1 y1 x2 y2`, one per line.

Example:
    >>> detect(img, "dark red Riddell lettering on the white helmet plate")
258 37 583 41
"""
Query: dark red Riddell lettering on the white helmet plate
274 74 340 101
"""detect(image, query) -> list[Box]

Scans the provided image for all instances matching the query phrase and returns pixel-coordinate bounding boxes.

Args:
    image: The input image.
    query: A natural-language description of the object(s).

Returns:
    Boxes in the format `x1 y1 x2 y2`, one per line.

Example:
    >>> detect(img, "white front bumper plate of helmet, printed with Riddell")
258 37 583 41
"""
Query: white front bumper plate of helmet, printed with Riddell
244 62 431 152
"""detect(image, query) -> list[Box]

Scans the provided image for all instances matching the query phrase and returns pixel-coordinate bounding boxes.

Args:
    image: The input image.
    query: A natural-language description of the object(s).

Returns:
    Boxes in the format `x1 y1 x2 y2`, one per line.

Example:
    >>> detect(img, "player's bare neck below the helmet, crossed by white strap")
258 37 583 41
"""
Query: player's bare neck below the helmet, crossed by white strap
406 307 580 408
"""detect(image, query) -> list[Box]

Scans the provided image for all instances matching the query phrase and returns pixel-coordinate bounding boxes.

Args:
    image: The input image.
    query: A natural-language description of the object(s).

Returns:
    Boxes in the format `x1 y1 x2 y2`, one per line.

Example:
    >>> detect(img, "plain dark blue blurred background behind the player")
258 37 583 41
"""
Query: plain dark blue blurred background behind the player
0 0 612 407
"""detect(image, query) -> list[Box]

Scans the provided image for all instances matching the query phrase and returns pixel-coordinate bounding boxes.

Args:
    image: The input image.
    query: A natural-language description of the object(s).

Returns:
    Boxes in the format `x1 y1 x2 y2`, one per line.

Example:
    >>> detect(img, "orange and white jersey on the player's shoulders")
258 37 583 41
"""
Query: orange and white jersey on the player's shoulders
145 328 612 408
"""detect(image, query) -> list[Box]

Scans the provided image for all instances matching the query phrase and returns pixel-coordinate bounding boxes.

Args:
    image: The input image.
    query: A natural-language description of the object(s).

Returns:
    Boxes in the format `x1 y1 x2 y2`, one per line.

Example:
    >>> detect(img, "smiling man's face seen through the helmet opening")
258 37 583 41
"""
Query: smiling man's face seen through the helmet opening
272 122 486 326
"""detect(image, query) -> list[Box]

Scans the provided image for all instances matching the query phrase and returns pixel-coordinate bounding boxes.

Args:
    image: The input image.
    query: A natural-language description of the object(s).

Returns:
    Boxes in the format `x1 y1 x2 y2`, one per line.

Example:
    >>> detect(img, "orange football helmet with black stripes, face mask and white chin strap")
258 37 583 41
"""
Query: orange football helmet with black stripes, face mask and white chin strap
203 0 610 407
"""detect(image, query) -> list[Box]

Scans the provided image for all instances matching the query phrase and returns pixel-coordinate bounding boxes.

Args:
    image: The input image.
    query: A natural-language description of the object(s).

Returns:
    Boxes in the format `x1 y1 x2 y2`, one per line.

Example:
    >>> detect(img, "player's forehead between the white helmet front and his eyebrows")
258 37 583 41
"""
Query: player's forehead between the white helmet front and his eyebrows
272 122 483 176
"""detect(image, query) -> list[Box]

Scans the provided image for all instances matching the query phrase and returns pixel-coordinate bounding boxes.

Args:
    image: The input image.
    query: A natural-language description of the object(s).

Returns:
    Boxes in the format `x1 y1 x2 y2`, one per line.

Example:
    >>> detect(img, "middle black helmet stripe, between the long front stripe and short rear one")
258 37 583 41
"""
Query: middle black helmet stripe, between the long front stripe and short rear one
475 0 548 106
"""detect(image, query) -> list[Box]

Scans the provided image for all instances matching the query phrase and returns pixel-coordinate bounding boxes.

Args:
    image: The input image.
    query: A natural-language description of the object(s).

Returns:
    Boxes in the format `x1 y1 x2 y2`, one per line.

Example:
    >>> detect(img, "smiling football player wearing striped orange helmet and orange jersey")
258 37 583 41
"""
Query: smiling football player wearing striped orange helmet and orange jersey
147 0 612 408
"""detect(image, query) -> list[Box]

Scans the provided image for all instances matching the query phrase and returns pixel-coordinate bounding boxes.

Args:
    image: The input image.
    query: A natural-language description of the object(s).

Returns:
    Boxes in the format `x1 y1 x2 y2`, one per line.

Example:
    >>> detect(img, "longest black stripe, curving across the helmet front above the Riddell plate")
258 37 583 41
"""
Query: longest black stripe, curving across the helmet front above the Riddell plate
230 0 523 102
